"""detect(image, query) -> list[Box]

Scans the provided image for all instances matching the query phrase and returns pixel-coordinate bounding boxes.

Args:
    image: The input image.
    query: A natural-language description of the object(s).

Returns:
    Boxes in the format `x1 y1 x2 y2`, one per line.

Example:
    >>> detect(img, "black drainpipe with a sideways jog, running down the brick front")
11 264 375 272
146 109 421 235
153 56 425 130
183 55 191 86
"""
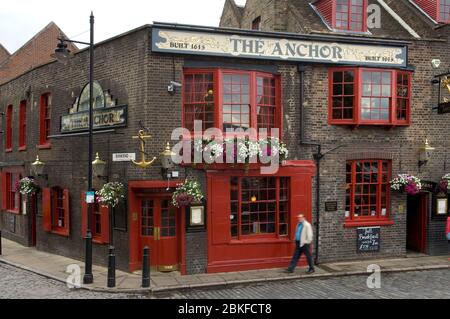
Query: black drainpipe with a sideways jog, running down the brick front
298 64 324 265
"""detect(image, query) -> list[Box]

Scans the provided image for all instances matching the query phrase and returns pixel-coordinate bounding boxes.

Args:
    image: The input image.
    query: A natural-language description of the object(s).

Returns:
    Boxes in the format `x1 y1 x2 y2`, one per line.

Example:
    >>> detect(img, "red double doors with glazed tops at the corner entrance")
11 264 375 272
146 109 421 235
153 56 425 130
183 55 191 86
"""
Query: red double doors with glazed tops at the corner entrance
140 197 179 271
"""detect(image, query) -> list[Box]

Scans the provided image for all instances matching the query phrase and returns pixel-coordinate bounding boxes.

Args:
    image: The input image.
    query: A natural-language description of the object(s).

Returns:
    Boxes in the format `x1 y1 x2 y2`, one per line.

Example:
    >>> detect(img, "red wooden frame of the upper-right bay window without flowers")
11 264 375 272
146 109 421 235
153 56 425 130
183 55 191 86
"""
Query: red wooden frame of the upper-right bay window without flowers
328 67 412 126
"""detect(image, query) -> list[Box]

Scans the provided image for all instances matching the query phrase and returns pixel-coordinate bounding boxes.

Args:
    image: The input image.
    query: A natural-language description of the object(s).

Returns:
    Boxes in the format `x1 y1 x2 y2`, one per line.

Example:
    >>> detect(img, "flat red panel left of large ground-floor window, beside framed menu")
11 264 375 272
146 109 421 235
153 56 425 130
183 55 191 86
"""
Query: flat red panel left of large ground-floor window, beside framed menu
208 175 231 245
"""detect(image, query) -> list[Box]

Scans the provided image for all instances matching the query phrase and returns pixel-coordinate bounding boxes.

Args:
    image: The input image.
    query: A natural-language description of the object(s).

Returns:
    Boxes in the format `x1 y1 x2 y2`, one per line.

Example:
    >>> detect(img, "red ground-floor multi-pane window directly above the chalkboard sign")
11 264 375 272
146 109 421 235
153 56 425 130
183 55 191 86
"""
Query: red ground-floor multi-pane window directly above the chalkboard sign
345 159 393 227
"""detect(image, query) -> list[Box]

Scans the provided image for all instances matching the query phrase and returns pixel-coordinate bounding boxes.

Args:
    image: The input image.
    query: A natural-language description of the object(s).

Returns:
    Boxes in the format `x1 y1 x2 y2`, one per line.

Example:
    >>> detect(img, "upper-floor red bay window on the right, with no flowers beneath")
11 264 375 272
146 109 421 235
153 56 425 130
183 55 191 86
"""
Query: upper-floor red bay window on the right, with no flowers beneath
329 68 411 126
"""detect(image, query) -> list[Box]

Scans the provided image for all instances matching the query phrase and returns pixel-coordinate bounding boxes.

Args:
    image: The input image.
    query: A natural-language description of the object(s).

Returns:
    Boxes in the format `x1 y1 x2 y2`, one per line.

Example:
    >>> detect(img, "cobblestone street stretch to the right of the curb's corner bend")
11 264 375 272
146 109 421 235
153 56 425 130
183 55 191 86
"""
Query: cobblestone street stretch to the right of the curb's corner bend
166 270 450 300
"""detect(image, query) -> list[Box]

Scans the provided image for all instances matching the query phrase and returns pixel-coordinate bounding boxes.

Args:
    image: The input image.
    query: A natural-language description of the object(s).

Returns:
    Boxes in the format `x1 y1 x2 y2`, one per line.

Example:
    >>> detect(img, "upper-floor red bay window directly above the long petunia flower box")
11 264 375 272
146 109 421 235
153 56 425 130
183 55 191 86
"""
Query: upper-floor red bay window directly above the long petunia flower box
183 69 281 133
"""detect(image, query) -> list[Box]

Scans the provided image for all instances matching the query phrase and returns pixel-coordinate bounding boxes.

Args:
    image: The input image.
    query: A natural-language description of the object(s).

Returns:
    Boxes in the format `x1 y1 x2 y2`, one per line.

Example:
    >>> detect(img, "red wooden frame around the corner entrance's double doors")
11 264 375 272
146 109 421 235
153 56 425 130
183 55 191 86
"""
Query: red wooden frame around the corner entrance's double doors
128 180 186 274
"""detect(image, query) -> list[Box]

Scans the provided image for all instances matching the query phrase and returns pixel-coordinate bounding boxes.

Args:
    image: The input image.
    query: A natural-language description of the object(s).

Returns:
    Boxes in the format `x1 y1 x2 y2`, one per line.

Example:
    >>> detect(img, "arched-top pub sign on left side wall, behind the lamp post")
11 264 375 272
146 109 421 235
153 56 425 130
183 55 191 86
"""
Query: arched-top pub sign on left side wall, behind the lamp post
61 82 128 134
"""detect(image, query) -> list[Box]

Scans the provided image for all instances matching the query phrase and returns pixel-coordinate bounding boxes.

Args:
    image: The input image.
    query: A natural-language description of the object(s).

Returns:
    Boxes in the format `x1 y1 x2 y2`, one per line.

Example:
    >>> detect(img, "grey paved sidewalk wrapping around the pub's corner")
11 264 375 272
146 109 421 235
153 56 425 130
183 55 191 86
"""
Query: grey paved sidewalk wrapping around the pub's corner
0 239 450 293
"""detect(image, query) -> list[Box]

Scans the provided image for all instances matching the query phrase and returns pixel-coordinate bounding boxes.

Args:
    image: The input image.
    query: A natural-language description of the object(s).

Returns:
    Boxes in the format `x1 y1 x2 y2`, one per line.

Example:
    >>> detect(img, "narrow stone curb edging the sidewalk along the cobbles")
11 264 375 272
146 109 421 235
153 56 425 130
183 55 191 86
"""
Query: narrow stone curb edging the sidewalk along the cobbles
0 257 450 294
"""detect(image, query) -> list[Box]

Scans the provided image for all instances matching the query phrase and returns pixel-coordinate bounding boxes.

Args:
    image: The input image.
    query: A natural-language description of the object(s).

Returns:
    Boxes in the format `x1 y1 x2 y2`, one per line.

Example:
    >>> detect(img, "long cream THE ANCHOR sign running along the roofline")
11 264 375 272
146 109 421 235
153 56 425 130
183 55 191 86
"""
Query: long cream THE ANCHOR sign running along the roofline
152 25 408 67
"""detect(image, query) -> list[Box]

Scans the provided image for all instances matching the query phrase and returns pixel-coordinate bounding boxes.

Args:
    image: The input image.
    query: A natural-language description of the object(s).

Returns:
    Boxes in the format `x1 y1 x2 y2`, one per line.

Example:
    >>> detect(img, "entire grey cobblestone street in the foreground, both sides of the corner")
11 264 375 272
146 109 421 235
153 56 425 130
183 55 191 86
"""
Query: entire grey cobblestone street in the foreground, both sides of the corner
0 264 450 300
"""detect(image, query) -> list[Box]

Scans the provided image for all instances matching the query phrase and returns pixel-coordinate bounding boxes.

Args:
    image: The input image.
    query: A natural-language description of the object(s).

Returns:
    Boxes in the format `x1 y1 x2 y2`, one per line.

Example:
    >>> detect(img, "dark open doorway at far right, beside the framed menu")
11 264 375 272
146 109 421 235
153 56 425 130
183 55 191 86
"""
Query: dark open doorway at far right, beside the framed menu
407 194 429 254
